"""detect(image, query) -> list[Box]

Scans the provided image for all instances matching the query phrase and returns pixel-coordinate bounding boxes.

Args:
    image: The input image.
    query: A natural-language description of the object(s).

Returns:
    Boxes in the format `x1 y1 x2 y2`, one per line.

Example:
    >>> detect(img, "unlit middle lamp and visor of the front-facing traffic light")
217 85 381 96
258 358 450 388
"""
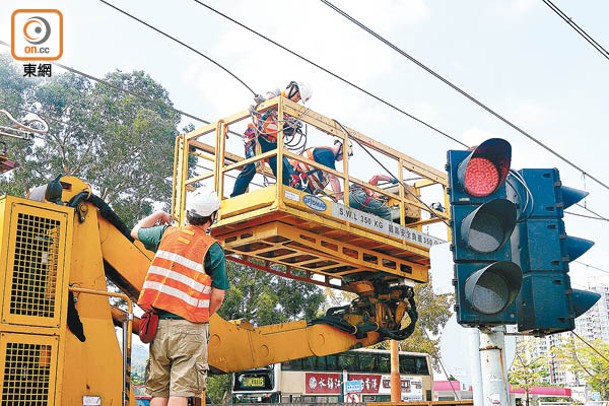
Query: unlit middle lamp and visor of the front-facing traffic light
461 199 517 254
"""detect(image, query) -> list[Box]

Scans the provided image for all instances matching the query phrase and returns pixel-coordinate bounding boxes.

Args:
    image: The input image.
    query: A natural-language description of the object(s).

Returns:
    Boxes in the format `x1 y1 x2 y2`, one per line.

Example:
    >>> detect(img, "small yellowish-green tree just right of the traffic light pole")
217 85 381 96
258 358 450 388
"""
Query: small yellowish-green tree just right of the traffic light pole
508 338 549 406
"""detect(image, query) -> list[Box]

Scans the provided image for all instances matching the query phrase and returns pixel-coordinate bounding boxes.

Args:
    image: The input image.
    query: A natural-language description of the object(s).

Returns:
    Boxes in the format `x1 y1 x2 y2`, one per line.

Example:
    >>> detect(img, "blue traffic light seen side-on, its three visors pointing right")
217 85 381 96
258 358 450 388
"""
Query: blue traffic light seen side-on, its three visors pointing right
512 169 600 335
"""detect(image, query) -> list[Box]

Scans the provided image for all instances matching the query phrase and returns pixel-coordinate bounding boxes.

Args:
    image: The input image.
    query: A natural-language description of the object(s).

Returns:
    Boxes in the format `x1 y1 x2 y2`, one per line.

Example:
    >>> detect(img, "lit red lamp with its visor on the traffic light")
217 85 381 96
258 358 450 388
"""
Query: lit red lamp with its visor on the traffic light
458 138 512 197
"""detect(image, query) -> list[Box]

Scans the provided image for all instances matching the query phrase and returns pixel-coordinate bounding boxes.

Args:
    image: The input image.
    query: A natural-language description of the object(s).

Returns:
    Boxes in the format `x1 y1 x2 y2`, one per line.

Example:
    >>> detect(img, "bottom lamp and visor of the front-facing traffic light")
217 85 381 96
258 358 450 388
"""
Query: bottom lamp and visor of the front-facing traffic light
465 261 522 314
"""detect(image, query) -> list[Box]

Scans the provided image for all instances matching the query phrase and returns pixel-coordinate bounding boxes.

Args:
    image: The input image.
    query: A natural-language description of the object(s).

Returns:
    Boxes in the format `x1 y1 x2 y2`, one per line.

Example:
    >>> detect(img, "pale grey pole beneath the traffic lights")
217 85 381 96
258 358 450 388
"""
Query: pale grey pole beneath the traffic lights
480 326 509 406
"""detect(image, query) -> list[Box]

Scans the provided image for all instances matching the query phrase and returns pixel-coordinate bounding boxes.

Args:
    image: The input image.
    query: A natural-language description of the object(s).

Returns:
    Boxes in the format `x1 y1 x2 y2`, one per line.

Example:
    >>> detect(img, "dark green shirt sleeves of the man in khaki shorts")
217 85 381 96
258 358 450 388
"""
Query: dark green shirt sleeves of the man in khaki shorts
137 225 230 290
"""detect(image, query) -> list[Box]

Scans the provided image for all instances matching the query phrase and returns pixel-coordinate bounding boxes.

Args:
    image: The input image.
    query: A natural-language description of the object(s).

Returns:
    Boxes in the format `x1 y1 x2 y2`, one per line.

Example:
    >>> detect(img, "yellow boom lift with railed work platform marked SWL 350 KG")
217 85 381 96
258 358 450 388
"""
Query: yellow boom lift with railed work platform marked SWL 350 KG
0 97 447 405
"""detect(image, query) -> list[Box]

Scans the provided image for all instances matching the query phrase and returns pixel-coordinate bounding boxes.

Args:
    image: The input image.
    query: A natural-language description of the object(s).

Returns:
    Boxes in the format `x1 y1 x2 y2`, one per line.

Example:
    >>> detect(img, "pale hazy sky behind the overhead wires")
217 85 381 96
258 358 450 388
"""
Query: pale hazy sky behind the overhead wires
0 0 609 287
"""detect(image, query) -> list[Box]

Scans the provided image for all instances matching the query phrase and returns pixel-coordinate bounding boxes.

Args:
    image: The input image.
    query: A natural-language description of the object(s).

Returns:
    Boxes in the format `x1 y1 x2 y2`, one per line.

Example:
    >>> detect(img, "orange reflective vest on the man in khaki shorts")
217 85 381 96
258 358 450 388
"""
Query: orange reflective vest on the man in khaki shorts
137 226 216 323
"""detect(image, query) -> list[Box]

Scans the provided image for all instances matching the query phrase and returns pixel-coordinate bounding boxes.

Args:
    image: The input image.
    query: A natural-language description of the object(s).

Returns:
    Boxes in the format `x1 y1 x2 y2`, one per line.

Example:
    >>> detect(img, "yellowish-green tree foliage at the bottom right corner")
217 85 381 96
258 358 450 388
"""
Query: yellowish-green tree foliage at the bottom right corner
553 336 609 401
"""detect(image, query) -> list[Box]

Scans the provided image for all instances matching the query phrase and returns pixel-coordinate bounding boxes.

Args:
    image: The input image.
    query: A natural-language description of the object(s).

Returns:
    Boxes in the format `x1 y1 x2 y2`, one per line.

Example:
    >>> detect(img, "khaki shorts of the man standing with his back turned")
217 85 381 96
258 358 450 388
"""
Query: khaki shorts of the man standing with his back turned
146 319 209 398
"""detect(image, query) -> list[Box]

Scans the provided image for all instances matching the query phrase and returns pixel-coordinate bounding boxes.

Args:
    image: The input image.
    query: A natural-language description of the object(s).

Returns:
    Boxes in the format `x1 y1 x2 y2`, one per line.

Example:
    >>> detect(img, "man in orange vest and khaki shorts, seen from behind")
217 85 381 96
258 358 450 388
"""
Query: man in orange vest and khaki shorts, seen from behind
131 187 230 406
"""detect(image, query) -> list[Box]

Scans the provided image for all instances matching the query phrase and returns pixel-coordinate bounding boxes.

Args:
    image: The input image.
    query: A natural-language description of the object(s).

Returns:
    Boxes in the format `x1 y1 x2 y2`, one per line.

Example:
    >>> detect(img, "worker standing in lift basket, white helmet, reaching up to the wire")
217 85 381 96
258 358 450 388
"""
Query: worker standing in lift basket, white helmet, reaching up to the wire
230 81 313 197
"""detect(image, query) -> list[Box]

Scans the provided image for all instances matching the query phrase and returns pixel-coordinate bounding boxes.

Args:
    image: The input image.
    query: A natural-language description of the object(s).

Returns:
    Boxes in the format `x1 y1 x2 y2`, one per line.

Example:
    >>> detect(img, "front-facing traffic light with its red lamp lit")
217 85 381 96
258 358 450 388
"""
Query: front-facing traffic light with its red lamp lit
447 138 522 326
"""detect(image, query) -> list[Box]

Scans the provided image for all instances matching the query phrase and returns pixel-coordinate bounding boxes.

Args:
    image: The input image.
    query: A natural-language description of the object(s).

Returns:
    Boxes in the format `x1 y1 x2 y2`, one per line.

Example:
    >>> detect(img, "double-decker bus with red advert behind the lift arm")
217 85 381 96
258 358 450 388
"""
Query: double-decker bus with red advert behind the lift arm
232 349 433 403
